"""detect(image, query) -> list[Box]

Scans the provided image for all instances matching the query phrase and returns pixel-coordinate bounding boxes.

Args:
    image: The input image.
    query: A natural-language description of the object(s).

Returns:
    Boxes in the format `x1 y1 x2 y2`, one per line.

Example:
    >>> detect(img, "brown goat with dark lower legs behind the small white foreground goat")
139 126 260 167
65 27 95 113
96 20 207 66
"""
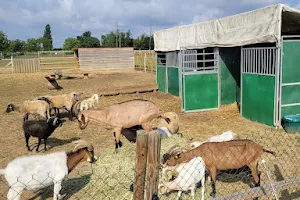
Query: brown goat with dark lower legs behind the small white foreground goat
163 139 275 197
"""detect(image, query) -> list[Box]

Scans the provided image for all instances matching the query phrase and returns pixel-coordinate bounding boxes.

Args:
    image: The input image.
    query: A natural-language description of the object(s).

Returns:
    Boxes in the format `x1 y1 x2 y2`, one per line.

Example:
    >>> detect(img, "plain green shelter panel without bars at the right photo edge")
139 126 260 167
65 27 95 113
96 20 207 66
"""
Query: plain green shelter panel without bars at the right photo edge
281 38 300 118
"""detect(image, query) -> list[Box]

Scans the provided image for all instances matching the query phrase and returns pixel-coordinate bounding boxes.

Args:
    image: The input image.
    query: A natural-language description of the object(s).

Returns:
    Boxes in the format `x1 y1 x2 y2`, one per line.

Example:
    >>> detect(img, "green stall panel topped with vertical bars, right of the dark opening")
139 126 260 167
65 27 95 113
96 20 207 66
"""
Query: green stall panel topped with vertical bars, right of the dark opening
241 47 278 126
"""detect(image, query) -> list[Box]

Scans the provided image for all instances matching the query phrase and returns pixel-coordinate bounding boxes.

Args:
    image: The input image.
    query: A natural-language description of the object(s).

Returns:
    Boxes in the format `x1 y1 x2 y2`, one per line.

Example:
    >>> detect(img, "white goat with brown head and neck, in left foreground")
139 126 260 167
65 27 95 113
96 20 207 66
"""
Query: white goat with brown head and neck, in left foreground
0 140 97 200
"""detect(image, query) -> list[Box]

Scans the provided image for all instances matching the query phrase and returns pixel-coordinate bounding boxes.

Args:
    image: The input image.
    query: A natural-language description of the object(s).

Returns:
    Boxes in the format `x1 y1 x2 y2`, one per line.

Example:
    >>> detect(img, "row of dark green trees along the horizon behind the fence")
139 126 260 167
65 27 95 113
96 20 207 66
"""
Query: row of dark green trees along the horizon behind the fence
0 24 154 52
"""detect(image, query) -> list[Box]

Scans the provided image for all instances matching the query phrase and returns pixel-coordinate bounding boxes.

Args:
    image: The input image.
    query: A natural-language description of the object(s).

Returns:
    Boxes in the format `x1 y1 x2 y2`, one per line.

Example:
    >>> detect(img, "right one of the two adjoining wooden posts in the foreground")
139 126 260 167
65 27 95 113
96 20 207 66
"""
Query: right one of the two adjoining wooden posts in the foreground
146 130 161 200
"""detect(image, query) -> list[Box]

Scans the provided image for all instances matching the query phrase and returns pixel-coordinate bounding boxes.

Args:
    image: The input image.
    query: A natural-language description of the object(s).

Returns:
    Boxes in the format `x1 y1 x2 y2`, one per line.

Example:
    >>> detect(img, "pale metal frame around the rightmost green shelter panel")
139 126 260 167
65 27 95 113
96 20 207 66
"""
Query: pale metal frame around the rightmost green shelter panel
276 35 300 126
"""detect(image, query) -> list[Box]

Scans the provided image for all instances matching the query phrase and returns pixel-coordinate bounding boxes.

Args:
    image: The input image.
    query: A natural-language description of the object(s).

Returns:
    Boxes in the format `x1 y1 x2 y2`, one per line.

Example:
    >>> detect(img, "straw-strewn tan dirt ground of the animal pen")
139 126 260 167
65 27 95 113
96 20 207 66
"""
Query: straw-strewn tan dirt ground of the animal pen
0 72 300 200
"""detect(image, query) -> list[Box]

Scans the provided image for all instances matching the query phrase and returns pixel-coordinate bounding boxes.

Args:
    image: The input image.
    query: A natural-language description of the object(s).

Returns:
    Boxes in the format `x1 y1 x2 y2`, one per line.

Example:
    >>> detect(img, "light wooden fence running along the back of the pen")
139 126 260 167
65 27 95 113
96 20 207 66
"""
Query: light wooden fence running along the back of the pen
0 48 156 73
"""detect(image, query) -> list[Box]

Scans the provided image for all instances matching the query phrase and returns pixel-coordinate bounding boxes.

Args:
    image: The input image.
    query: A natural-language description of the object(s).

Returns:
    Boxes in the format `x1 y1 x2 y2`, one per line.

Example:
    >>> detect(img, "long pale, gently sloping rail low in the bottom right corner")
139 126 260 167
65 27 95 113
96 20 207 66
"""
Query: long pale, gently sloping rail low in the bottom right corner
213 177 300 200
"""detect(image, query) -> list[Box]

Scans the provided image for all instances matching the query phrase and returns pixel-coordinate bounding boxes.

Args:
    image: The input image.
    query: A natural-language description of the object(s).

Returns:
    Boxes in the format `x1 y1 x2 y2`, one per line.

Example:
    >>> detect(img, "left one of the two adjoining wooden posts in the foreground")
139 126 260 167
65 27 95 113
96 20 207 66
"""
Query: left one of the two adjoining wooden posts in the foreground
133 131 148 200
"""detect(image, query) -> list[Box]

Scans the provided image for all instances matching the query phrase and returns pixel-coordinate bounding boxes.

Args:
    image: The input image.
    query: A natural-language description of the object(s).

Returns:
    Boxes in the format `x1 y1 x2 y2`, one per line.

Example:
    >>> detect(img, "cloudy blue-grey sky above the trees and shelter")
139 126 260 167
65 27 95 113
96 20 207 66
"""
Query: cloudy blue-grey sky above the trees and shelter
0 0 300 48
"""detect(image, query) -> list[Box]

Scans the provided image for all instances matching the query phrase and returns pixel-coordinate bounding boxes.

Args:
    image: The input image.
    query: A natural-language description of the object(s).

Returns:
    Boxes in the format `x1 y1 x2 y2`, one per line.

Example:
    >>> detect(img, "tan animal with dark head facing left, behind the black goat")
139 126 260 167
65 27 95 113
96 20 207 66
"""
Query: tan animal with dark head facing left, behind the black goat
6 100 50 121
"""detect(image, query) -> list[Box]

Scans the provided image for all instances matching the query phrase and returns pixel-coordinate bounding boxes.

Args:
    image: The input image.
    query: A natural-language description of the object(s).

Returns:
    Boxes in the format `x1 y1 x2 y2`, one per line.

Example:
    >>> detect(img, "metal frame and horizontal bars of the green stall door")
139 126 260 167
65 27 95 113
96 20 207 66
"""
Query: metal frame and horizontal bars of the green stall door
178 47 221 113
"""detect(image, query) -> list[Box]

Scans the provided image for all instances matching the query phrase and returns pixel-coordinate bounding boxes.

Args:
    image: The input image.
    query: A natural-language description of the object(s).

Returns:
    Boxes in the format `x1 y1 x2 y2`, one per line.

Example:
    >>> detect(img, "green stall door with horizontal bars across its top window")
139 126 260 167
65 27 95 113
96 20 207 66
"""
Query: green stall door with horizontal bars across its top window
181 48 220 112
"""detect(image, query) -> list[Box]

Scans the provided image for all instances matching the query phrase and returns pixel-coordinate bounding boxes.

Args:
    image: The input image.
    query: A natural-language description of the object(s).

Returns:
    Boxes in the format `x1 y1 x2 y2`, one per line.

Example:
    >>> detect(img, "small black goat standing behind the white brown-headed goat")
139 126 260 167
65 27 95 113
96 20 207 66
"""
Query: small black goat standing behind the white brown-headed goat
23 118 62 151
